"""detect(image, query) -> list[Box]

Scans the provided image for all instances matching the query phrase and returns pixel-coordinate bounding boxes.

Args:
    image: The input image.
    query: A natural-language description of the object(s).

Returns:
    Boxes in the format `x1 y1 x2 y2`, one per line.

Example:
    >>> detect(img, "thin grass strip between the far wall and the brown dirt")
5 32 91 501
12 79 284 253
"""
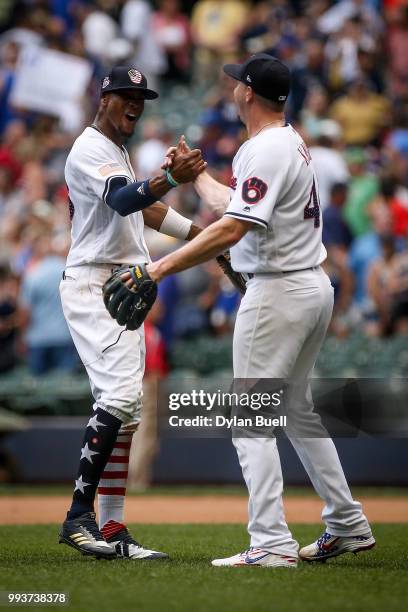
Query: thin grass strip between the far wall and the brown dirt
0 484 408 498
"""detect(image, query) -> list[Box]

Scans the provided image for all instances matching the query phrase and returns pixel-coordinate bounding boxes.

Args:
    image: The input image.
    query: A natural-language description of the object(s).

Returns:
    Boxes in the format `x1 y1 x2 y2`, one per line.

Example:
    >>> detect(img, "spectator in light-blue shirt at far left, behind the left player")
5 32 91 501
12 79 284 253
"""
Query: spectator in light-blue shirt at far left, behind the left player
20 231 78 376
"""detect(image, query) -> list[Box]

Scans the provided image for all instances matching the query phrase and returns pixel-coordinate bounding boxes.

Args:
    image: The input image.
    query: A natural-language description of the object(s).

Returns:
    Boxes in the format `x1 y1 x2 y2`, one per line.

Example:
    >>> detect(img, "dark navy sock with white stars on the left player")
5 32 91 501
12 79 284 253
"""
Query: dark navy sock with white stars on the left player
67 408 122 520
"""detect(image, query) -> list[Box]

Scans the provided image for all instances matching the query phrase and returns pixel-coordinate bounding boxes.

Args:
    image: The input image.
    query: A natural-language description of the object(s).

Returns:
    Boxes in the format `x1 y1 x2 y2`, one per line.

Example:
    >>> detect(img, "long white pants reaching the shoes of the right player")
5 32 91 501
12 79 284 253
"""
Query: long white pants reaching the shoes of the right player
233 267 370 556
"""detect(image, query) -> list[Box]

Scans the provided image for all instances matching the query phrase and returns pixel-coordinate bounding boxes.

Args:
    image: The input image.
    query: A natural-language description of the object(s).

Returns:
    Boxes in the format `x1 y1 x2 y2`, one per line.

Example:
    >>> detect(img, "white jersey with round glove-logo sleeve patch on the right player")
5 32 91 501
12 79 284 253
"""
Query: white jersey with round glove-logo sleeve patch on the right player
225 125 326 273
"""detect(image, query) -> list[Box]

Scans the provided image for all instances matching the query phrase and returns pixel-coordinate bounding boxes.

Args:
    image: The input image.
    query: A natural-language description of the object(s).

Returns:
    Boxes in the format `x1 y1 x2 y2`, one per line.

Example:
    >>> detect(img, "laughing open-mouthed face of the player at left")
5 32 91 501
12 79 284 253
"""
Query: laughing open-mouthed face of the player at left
105 89 144 138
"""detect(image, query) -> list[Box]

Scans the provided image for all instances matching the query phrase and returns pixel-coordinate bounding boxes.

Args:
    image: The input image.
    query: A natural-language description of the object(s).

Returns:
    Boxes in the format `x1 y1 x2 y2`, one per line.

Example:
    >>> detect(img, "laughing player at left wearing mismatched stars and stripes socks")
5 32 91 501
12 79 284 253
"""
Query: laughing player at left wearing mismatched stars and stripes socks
60 66 205 559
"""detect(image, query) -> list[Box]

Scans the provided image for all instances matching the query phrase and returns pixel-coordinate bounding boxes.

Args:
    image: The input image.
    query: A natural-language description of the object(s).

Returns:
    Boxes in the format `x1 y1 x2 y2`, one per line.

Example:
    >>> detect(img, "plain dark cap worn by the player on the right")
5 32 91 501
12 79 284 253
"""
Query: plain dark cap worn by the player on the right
224 53 290 102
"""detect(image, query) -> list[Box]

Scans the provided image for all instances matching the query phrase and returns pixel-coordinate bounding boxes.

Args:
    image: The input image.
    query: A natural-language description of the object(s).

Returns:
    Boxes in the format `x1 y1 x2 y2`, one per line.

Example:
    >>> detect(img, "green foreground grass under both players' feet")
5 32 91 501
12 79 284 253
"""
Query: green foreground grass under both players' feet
0 524 408 612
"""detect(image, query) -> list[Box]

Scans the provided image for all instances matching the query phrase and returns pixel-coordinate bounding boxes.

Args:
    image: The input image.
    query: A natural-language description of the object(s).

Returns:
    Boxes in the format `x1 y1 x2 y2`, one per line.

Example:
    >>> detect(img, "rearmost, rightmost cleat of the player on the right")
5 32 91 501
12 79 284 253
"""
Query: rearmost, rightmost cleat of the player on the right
299 531 375 561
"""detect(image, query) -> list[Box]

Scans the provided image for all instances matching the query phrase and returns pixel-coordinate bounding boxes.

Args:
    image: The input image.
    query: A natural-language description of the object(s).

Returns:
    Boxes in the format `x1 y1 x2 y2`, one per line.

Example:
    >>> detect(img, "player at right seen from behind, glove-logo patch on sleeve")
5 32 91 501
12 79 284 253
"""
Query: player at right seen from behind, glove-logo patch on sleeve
123 53 375 567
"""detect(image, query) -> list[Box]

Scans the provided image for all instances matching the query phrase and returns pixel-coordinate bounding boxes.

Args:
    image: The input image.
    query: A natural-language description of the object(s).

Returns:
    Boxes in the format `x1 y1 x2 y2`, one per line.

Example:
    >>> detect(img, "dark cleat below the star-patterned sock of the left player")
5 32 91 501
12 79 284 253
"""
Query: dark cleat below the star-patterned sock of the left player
59 512 116 559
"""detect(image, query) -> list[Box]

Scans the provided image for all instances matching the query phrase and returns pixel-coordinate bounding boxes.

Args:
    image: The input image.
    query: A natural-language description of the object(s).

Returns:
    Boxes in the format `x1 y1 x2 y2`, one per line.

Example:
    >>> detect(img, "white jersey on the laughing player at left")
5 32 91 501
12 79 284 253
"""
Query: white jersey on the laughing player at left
65 127 150 267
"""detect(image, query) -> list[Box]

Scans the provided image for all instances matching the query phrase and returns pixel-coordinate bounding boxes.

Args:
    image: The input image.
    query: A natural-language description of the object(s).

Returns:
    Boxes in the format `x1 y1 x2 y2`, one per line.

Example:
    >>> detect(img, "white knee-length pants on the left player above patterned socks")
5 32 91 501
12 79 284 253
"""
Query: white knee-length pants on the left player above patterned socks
60 264 145 426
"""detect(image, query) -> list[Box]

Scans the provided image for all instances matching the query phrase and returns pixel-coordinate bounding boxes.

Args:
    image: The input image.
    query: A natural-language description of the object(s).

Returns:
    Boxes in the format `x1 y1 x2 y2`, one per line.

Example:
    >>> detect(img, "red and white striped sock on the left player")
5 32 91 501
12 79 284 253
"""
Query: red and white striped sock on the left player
98 431 133 535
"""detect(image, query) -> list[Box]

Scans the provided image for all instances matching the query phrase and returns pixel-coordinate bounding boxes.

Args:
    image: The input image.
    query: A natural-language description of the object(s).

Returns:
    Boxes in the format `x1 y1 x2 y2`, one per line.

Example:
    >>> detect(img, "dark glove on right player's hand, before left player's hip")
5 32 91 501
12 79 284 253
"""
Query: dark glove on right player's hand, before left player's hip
102 264 157 330
